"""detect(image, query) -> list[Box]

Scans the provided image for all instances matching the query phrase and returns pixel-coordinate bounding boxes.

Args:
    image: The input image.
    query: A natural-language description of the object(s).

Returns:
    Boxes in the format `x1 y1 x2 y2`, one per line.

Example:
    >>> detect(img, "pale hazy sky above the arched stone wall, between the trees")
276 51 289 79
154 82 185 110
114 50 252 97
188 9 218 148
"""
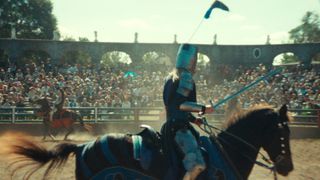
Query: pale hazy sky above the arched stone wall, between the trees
52 0 320 45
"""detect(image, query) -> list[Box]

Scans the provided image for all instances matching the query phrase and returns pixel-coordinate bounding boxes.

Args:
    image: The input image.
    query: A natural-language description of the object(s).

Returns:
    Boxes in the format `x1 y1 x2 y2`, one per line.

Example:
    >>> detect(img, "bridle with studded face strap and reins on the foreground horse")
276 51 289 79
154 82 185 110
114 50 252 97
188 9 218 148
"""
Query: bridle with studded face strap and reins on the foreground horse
199 117 288 180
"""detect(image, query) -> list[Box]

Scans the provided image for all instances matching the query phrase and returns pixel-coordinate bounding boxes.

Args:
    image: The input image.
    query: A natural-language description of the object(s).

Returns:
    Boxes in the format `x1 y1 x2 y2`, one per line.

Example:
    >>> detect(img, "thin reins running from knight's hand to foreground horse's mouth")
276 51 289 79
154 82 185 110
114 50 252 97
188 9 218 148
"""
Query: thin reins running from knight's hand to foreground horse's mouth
199 117 285 180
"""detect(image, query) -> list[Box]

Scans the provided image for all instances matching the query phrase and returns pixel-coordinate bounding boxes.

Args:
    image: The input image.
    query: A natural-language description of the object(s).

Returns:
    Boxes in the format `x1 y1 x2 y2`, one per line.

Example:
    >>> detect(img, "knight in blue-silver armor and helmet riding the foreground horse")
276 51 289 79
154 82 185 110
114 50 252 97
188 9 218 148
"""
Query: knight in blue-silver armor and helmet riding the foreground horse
161 44 213 180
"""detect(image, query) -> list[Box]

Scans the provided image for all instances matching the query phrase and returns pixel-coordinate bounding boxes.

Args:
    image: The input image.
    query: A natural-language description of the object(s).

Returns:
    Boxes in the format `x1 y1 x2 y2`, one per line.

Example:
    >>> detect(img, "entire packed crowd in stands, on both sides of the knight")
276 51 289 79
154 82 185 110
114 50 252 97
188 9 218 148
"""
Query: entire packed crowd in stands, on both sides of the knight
0 60 320 112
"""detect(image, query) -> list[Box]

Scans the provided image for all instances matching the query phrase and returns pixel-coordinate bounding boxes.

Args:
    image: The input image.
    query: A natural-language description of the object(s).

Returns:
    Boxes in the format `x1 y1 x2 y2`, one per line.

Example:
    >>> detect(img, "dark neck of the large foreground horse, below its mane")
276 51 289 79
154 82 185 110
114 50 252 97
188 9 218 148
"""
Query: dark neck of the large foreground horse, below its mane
219 121 260 179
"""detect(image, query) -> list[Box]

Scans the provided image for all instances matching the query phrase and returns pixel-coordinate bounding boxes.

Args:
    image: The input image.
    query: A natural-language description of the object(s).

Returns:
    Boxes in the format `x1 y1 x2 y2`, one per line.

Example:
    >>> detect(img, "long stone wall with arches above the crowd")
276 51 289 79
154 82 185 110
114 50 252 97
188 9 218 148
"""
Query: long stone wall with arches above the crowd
0 39 320 70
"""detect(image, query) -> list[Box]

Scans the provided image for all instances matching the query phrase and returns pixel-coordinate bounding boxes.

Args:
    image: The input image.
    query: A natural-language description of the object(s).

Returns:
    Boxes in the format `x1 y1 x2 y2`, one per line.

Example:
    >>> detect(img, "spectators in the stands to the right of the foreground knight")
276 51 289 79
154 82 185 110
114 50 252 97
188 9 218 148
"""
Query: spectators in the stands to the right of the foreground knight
199 64 320 109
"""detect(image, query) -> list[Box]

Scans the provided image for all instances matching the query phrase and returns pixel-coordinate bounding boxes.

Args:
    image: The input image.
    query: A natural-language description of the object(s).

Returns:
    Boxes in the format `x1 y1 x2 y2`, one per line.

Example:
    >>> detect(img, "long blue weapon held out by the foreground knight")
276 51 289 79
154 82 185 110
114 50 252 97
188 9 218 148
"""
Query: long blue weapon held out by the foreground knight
210 68 282 109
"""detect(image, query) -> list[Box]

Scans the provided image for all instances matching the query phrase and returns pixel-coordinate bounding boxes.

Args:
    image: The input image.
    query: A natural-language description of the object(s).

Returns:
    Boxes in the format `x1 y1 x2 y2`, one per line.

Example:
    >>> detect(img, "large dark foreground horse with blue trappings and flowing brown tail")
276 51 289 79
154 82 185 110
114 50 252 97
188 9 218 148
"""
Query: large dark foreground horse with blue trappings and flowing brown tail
6 105 293 180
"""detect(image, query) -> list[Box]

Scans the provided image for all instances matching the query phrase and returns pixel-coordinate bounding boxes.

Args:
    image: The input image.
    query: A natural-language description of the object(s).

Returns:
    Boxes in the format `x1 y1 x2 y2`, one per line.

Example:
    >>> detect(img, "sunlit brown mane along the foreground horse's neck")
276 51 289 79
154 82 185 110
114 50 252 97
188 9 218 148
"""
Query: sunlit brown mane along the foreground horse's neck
223 103 292 128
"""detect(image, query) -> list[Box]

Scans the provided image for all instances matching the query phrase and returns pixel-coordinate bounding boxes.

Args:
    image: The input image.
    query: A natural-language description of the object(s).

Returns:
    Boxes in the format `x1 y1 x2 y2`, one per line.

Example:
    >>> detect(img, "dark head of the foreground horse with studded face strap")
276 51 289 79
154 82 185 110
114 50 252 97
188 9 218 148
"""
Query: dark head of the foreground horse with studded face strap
262 105 293 176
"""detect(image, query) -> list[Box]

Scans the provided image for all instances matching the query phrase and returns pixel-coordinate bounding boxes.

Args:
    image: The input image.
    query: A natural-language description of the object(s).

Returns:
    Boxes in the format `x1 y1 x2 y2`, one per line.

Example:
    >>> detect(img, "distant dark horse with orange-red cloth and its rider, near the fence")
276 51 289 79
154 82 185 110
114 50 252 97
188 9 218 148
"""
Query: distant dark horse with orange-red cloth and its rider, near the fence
32 89 90 140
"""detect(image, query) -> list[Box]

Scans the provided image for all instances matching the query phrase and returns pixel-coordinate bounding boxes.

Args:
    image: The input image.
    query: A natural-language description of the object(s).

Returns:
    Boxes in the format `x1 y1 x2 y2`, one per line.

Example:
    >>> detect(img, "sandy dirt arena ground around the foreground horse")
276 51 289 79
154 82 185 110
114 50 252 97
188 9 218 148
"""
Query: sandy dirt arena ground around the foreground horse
0 135 320 180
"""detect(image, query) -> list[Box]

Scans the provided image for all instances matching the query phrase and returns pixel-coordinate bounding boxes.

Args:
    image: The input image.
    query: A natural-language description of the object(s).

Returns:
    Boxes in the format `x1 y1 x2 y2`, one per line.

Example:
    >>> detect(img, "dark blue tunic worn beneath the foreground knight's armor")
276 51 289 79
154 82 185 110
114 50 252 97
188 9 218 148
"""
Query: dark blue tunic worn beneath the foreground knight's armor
161 78 199 180
